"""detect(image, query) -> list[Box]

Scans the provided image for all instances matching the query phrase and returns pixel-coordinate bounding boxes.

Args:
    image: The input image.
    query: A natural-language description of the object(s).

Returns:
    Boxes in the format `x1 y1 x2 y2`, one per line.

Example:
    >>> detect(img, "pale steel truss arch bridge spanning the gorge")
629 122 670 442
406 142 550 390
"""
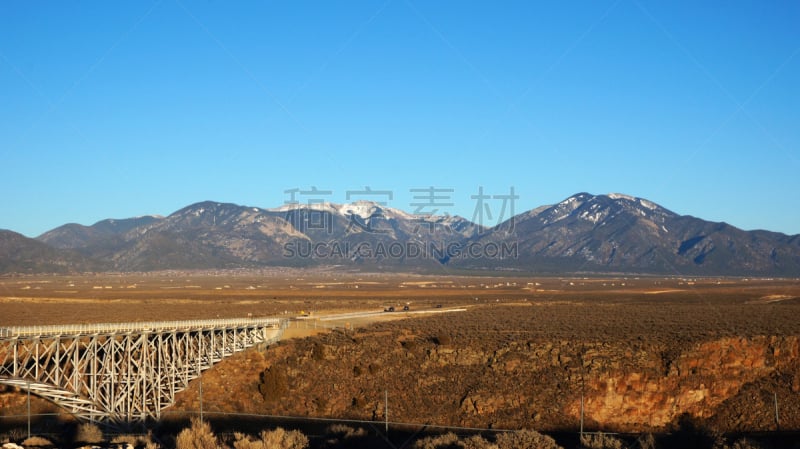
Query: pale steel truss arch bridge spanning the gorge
0 318 288 423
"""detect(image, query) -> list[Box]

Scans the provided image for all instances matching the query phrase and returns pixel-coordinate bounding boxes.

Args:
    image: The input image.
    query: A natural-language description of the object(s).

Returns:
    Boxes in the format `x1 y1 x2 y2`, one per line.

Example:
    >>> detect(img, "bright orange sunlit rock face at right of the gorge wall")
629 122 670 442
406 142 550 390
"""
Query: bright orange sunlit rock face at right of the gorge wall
567 336 800 427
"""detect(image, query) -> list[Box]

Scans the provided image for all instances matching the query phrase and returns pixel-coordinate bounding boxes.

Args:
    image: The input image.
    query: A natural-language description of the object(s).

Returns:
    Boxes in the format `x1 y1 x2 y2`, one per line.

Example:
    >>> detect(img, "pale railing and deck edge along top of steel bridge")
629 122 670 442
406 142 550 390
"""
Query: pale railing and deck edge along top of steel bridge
0 318 285 338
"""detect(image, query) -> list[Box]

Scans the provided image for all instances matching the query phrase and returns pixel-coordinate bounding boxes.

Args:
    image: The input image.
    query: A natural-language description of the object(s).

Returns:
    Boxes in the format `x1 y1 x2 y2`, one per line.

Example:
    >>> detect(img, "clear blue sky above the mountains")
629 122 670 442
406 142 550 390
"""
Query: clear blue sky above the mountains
0 0 800 236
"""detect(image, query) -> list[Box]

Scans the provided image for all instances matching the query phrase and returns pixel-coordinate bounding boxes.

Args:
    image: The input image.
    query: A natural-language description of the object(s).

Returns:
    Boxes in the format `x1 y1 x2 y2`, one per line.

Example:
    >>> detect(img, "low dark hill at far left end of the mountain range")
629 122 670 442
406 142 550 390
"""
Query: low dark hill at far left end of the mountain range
0 229 101 273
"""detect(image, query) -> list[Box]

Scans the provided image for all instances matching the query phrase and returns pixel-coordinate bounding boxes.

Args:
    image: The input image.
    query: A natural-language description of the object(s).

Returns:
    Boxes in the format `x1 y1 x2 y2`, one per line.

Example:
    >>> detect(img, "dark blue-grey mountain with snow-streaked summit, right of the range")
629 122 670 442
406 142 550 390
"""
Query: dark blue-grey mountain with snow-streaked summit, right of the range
462 193 800 276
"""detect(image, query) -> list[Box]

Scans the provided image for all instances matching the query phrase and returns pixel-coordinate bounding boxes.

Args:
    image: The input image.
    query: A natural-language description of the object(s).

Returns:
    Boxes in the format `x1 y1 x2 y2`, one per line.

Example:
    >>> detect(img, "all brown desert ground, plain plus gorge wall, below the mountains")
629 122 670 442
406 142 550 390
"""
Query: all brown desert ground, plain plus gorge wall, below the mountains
0 269 800 446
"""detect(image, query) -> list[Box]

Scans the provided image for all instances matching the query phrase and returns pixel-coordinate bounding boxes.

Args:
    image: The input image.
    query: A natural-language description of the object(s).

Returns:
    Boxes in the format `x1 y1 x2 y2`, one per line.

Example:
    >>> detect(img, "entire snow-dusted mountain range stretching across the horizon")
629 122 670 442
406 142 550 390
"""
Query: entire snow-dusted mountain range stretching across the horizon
0 193 800 276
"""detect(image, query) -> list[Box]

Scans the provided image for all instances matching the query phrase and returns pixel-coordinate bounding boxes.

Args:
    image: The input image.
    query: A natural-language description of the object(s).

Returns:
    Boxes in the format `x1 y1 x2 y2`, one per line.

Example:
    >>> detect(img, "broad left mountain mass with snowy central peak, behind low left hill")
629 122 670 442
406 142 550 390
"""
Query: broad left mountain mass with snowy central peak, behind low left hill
28 201 483 271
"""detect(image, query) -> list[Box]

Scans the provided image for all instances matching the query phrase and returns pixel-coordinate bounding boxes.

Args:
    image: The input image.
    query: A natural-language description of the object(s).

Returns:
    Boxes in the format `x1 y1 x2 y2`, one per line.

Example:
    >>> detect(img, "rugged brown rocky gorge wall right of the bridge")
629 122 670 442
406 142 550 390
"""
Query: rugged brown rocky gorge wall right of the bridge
173 316 800 431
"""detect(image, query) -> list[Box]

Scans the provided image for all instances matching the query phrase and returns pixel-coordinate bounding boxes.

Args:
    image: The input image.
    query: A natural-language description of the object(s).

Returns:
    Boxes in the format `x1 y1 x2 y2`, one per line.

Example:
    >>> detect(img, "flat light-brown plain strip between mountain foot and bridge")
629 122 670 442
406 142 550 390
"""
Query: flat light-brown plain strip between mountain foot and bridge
0 269 800 326
